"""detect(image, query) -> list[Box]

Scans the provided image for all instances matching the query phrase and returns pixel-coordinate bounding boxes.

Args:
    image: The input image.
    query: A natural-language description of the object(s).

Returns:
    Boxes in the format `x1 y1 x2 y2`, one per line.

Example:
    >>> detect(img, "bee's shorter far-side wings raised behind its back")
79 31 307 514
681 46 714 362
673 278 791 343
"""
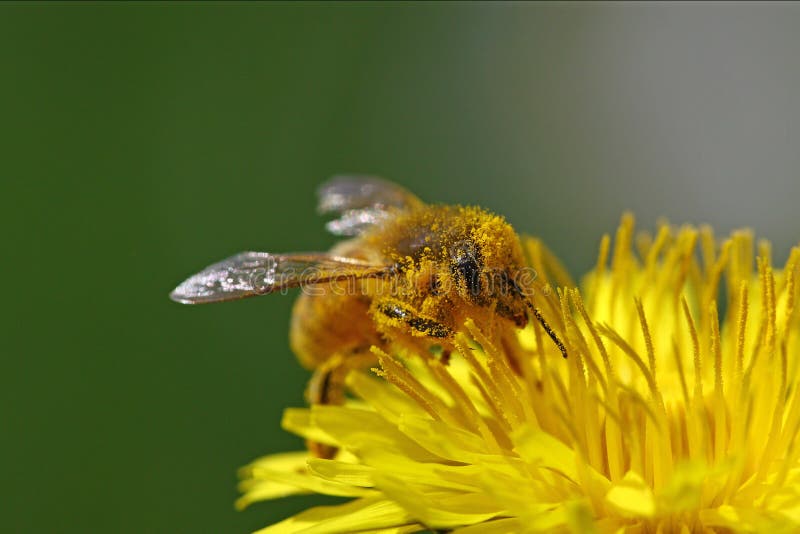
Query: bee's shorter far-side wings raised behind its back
317 176 422 236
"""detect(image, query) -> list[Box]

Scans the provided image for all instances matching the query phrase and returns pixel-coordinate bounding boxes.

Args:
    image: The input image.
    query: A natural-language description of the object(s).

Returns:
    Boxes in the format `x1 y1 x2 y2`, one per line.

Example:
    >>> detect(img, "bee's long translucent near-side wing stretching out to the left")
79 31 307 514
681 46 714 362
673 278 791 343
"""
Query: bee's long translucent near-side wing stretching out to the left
169 252 392 304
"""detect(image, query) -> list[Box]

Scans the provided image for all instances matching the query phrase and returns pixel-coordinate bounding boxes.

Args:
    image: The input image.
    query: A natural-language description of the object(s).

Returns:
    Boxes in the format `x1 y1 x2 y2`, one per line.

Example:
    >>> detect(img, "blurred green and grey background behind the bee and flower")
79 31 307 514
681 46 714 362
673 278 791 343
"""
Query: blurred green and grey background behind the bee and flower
0 3 800 532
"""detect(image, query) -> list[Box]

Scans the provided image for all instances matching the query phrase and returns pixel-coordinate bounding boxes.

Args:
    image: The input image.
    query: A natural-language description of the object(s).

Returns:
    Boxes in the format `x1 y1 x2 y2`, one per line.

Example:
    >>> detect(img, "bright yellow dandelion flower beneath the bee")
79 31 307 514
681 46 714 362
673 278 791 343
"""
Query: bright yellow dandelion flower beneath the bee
237 216 800 534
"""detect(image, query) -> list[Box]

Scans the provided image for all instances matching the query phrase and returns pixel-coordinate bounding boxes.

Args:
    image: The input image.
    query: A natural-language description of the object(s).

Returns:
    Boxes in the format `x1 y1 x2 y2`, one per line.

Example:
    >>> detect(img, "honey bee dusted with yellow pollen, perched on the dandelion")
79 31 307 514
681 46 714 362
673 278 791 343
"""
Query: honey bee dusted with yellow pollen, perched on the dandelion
170 177 567 455
